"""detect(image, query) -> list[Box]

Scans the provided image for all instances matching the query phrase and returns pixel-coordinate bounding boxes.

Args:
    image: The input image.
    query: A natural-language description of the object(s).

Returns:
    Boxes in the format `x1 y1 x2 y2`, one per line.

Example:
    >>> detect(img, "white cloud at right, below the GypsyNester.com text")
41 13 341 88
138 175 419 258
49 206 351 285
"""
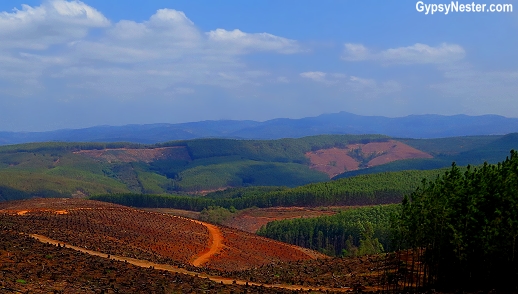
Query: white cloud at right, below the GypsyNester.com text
342 43 466 64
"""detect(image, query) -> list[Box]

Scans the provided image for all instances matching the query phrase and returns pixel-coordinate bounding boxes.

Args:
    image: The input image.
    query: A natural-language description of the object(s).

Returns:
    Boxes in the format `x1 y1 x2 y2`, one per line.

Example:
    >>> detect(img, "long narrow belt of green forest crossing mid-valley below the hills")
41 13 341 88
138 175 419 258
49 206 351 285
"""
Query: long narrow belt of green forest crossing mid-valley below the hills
91 170 444 211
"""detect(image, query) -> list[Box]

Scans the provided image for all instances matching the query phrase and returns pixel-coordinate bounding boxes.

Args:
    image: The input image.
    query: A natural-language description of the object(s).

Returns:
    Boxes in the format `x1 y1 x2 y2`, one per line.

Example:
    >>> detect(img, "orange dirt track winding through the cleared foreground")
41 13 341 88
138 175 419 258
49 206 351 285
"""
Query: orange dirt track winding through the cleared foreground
29 233 353 292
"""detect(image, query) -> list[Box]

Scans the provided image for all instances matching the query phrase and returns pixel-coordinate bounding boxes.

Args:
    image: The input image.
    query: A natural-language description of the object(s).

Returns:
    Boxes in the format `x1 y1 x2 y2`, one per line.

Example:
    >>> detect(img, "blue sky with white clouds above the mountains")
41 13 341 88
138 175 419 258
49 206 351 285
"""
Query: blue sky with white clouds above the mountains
0 0 518 131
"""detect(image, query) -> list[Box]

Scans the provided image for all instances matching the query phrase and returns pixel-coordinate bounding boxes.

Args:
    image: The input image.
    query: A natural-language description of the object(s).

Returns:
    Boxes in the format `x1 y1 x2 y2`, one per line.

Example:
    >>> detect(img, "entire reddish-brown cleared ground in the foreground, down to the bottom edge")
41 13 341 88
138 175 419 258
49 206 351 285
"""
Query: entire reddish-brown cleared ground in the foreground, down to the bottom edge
0 199 398 293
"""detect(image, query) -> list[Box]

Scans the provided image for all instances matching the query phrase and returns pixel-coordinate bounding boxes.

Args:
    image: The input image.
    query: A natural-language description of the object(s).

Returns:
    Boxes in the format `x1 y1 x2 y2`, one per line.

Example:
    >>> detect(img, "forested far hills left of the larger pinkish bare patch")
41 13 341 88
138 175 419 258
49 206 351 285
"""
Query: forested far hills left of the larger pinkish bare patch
0 135 386 200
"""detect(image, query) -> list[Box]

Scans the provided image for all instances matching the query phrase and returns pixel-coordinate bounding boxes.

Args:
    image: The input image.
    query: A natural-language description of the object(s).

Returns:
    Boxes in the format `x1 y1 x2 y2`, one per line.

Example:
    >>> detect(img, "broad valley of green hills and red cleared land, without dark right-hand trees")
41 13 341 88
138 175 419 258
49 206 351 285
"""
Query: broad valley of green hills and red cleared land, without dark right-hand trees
0 134 518 293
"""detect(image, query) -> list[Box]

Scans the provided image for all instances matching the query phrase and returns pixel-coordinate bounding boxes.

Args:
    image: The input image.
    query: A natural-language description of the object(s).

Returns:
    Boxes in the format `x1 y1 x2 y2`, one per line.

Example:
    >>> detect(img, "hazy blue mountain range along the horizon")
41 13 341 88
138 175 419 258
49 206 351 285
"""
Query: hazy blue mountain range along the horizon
0 112 518 145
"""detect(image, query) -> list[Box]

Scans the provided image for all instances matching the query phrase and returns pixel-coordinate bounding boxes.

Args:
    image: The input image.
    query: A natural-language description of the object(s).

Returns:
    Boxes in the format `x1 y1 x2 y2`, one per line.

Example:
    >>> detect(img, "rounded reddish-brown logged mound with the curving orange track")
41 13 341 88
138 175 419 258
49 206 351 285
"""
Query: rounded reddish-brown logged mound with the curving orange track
0 199 324 270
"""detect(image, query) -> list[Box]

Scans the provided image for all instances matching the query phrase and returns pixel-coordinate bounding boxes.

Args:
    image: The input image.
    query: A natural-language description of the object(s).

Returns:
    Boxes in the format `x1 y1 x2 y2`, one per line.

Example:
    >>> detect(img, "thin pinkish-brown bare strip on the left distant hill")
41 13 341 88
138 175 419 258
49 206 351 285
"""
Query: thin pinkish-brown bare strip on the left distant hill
74 146 191 162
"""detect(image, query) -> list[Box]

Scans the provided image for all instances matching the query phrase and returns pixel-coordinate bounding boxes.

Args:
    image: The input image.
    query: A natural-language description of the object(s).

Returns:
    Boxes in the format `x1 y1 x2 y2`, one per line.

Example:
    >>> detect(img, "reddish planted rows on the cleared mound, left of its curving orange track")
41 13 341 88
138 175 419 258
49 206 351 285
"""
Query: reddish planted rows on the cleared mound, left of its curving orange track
2 200 209 263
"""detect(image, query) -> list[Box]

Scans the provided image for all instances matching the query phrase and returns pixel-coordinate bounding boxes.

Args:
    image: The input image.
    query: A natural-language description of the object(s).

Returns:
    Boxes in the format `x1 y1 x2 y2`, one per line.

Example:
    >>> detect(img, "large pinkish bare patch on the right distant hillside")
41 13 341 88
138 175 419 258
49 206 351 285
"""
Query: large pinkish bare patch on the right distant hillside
306 140 432 178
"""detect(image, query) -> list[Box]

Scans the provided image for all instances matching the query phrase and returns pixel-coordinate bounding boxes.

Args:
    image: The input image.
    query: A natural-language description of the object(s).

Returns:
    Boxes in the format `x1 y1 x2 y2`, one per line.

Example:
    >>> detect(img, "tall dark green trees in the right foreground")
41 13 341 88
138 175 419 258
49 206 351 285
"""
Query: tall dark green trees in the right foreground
394 151 518 291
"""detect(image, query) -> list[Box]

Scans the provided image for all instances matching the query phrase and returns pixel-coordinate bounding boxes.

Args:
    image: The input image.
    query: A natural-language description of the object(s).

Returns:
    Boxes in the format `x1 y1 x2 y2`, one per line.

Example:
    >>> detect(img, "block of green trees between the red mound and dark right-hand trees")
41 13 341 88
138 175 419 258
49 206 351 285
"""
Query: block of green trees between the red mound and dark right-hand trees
257 204 401 256
